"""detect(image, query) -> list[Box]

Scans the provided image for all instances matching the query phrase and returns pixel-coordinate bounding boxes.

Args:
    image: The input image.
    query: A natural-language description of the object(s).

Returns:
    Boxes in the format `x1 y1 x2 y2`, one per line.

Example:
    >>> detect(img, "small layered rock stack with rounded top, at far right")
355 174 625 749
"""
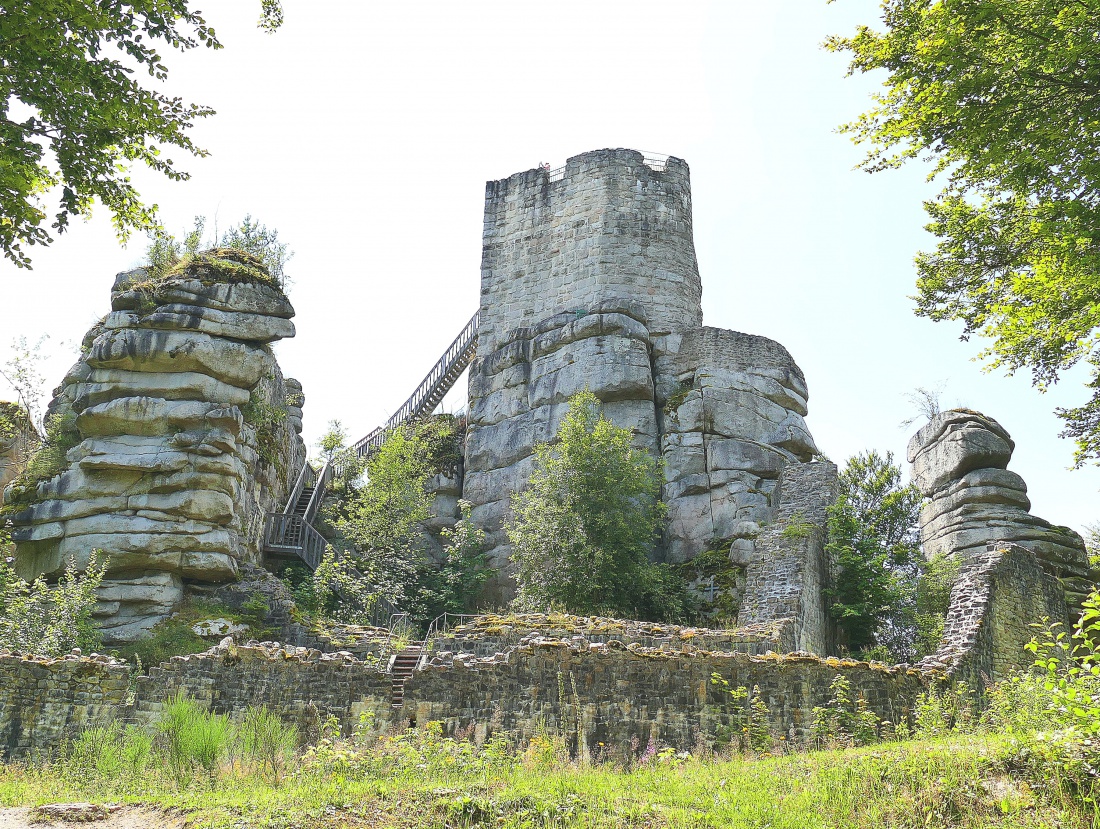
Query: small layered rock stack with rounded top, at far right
909 409 1092 607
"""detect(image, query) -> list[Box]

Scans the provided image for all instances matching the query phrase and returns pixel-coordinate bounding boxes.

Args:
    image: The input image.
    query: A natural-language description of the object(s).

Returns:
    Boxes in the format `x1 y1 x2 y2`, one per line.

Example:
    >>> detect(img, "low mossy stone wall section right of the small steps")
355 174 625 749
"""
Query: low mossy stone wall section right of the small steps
411 640 931 756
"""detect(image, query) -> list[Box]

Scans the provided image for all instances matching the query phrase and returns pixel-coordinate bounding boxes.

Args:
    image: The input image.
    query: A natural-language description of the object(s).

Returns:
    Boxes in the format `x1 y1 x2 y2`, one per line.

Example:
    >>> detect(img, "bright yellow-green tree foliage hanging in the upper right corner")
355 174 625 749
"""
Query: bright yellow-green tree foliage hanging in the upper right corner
827 0 1100 465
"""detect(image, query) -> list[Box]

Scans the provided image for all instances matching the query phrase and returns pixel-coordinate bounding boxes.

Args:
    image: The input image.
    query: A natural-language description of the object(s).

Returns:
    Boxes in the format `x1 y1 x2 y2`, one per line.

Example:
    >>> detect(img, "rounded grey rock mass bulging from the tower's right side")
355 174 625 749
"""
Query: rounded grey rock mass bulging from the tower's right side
656 328 817 564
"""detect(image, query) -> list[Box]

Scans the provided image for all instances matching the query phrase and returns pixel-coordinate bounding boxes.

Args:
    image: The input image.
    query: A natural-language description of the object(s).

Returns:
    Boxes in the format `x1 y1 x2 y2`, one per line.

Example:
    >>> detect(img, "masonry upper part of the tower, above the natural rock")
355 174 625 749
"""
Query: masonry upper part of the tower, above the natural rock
479 150 703 355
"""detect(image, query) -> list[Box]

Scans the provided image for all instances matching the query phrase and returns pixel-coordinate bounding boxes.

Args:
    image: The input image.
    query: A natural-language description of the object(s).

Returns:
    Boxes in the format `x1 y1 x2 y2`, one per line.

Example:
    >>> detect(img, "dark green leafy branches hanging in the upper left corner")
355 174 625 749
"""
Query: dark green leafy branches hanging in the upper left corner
0 0 283 267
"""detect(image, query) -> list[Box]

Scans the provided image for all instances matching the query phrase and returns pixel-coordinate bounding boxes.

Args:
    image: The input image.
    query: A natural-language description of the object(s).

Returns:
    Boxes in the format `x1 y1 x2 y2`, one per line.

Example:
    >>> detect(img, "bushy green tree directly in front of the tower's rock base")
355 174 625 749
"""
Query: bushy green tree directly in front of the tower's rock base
506 390 689 619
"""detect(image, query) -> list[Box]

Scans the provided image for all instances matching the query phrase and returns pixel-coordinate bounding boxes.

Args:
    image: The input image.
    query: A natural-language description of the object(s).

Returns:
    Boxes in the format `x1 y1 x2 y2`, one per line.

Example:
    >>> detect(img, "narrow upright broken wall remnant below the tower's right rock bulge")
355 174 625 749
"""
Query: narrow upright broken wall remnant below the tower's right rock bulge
734 462 837 653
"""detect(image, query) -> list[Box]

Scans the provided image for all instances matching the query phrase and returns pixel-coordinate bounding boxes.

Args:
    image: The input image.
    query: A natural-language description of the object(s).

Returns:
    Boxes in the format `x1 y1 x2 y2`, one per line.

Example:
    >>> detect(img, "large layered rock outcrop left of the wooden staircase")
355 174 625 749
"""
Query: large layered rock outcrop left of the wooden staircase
10 250 306 641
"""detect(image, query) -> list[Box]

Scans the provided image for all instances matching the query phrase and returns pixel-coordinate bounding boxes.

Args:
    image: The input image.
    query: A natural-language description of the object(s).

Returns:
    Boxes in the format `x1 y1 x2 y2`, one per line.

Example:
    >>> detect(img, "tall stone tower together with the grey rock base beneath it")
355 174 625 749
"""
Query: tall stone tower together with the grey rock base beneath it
462 150 835 643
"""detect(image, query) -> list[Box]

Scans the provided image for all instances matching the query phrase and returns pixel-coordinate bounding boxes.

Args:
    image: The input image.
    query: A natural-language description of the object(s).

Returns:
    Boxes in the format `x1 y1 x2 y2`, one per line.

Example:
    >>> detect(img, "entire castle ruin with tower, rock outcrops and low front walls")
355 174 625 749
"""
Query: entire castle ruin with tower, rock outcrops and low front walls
0 150 1096 755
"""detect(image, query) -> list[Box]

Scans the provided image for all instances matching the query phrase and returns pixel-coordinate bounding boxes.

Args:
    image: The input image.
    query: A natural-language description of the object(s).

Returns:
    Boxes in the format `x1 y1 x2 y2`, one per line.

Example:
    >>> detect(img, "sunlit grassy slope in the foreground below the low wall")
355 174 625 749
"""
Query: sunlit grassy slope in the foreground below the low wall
0 736 1097 829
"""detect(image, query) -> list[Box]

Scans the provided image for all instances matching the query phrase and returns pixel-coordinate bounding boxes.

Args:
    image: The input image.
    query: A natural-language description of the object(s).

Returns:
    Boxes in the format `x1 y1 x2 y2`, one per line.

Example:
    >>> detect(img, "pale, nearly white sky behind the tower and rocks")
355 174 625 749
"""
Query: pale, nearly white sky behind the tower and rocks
0 0 1100 530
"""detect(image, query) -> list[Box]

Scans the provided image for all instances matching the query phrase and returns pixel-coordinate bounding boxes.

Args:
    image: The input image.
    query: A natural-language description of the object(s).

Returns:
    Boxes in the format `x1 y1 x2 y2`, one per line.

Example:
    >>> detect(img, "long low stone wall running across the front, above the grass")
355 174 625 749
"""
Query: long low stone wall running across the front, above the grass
0 638 934 756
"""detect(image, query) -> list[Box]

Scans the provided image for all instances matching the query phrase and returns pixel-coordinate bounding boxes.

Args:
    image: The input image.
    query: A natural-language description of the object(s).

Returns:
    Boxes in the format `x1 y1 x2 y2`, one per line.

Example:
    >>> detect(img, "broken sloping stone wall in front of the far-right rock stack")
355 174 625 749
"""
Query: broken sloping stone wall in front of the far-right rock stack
921 542 1070 689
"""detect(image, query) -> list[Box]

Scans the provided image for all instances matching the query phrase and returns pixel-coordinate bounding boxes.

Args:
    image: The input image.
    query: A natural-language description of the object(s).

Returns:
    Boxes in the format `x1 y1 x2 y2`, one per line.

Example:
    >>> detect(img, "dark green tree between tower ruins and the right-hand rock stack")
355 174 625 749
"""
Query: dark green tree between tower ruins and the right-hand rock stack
826 451 921 652
